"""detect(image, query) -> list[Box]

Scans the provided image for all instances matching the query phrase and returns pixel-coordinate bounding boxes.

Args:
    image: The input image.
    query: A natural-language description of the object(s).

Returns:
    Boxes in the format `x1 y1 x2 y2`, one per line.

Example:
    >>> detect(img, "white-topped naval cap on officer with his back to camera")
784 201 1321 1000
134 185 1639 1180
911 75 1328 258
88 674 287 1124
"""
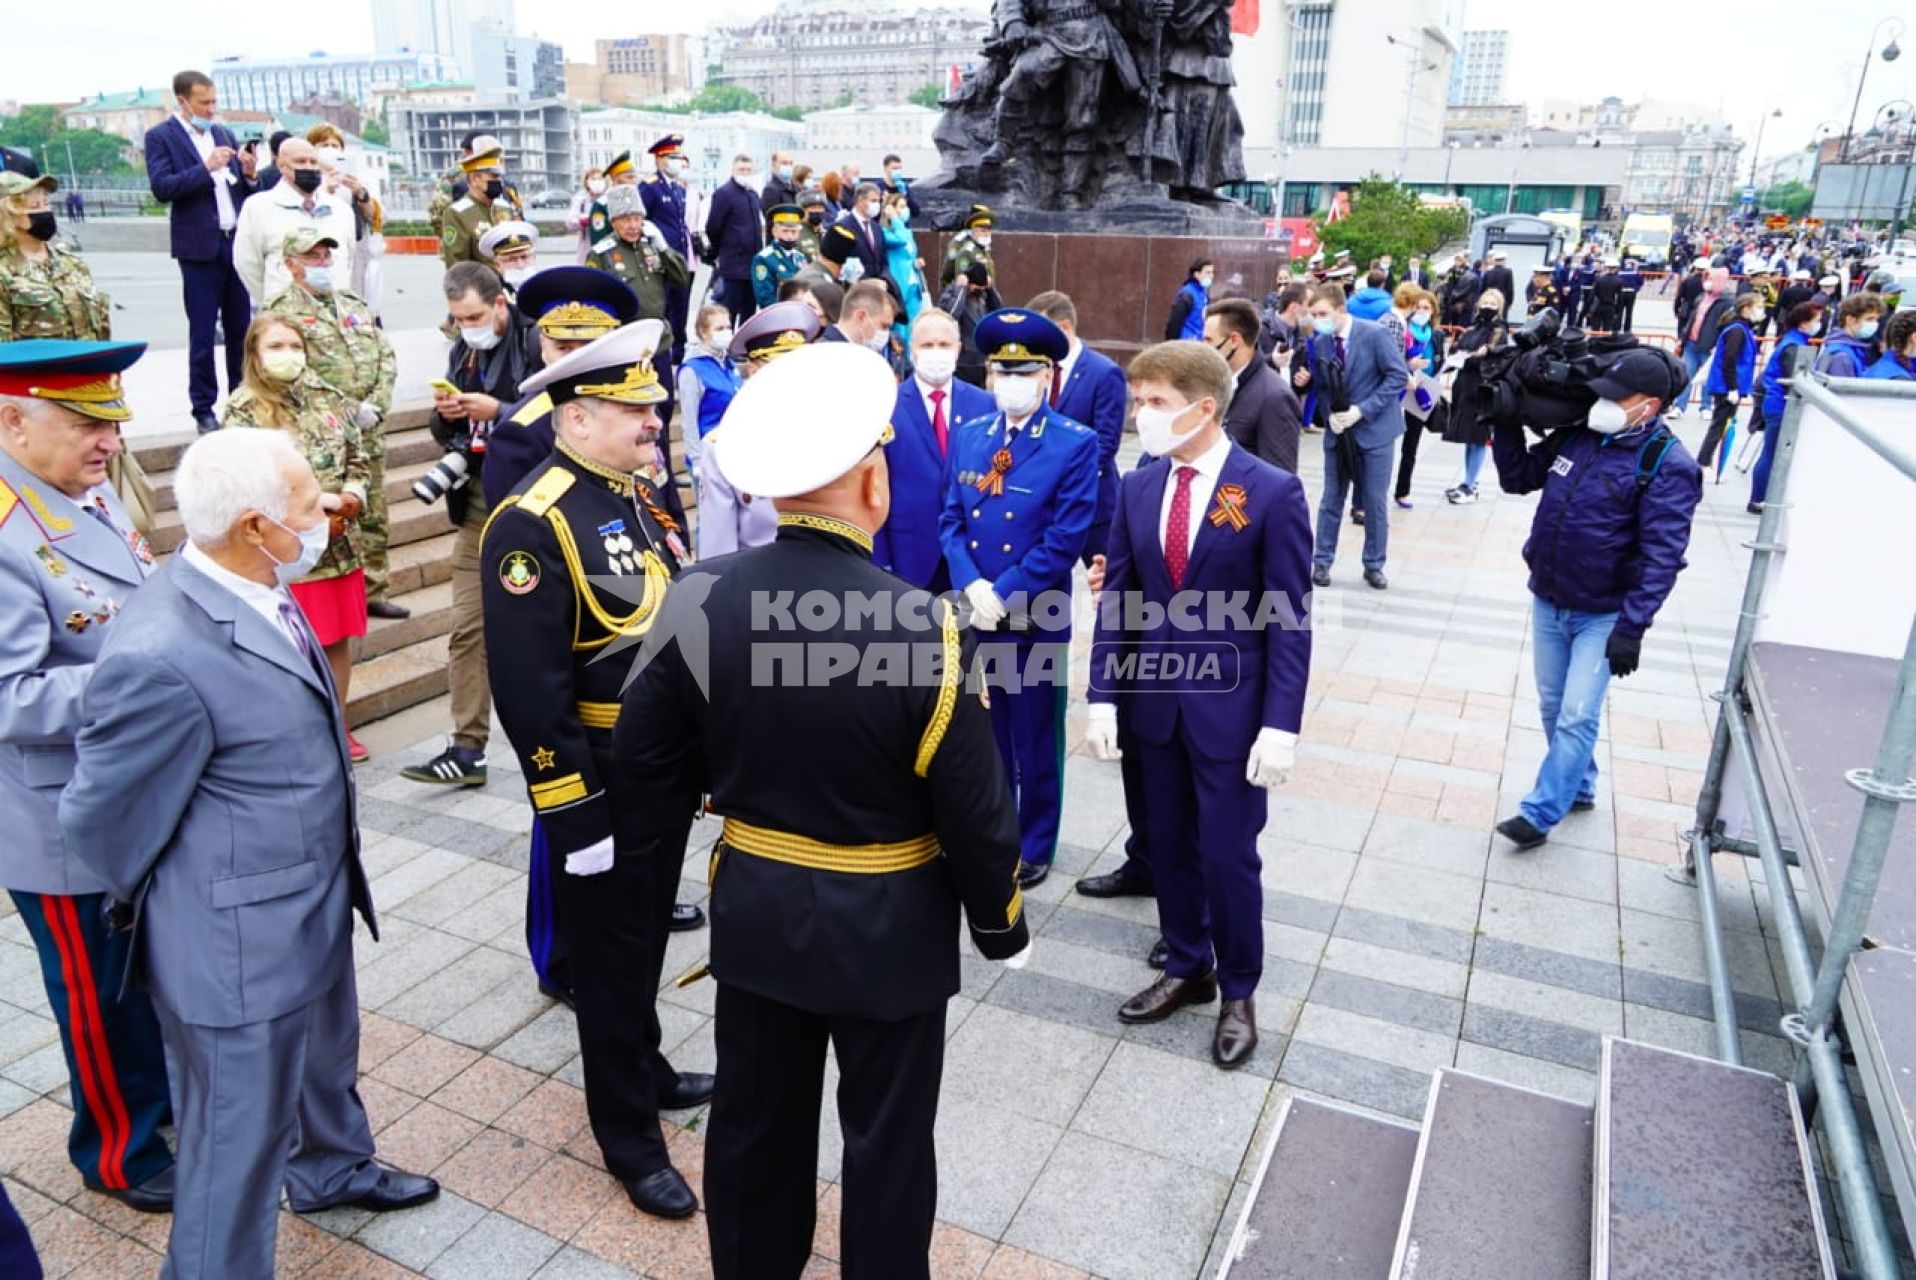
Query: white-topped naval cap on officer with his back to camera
705 346 899 498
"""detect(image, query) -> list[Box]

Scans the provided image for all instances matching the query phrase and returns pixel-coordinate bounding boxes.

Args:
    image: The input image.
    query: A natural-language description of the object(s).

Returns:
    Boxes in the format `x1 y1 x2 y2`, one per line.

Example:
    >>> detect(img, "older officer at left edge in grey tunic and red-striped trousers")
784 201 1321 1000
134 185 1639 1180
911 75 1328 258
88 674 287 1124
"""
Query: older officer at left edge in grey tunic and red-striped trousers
0 339 172 1211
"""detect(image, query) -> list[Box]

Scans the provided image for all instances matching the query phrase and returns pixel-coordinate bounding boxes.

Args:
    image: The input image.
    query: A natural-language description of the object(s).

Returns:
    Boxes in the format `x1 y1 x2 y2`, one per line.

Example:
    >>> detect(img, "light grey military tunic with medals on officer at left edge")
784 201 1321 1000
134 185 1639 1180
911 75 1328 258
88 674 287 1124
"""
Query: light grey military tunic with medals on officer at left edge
0 452 153 893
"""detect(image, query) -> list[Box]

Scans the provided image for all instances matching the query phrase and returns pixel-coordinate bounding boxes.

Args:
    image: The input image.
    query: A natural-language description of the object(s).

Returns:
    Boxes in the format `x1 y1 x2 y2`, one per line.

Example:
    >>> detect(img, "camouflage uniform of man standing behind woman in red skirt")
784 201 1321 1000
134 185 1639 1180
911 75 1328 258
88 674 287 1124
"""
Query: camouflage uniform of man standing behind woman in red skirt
266 287 399 604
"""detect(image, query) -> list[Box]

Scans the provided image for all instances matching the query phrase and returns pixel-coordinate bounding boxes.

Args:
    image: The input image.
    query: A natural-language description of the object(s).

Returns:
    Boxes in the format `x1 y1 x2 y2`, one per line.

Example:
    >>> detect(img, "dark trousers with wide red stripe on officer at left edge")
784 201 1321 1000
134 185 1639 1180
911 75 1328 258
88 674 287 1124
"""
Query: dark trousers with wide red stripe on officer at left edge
11 889 172 1190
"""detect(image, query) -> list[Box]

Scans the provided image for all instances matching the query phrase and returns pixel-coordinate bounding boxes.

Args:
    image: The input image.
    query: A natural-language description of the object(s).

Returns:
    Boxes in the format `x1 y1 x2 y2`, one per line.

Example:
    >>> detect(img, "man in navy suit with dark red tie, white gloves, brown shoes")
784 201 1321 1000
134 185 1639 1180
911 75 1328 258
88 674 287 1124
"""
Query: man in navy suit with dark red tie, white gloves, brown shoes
1084 343 1311 1067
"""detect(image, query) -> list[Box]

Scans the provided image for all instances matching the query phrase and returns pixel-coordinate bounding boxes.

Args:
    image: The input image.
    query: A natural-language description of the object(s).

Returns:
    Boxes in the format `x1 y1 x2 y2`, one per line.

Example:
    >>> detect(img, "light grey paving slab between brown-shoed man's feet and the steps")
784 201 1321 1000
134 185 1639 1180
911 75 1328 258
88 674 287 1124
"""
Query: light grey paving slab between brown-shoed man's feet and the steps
1071 1042 1270 1178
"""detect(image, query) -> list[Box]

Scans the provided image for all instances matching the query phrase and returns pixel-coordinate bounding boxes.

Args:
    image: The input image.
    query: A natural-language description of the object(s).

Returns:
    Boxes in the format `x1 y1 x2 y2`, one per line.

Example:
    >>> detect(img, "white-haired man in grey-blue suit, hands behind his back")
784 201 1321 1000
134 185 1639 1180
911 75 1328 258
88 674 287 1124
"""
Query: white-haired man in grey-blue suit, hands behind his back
59 431 439 1280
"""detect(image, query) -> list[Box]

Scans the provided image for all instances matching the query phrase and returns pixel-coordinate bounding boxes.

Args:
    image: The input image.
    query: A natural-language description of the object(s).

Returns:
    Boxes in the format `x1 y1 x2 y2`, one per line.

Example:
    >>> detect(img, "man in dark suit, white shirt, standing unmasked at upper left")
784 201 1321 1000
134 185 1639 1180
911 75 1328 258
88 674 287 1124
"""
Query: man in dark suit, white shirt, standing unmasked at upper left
146 71 255 431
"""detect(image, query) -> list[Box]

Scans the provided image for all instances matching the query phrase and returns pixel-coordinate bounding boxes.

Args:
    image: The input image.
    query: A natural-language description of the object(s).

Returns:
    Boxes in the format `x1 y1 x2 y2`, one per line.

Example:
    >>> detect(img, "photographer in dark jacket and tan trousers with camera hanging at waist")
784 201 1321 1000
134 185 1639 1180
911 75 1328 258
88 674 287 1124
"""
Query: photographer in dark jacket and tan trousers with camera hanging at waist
400 263 544 786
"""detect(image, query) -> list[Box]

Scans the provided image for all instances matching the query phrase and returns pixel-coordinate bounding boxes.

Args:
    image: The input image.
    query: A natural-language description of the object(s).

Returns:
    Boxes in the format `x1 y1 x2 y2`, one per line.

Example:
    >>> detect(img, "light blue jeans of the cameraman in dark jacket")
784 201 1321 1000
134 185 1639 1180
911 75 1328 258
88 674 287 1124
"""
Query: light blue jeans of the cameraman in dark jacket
1519 598 1617 832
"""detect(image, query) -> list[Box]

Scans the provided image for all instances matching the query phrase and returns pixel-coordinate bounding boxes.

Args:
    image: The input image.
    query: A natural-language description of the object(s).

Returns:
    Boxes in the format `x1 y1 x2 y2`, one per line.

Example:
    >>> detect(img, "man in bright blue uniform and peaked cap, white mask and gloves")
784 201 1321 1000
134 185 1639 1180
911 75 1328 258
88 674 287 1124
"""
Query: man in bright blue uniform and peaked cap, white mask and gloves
939 307 1098 889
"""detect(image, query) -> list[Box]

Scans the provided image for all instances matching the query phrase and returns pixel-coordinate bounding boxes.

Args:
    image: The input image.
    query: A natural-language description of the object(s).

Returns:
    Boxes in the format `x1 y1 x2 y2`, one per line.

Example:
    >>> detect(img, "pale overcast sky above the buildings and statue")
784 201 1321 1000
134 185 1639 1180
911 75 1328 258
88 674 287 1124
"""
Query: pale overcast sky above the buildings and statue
18 0 1916 169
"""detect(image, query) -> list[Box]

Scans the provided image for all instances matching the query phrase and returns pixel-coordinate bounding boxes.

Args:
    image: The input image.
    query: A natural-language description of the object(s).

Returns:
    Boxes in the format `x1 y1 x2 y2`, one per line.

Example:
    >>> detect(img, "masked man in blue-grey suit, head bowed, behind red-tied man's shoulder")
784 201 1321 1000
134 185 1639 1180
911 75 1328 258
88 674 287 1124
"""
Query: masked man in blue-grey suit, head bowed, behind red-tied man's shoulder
1305 286 1410 590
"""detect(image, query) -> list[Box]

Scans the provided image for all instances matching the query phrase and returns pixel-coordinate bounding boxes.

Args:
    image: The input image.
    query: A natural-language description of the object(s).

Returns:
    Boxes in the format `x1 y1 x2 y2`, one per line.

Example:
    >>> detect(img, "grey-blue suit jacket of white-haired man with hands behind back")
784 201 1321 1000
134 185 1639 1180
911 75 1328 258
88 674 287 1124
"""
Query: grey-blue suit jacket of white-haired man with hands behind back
59 560 377 1027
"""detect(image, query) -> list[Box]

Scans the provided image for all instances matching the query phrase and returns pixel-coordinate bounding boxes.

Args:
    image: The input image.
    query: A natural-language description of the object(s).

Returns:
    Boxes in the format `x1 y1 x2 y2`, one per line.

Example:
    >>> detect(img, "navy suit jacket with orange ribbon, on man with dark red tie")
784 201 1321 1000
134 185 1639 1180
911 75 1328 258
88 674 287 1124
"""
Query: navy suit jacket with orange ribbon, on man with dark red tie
1090 445 1311 768
